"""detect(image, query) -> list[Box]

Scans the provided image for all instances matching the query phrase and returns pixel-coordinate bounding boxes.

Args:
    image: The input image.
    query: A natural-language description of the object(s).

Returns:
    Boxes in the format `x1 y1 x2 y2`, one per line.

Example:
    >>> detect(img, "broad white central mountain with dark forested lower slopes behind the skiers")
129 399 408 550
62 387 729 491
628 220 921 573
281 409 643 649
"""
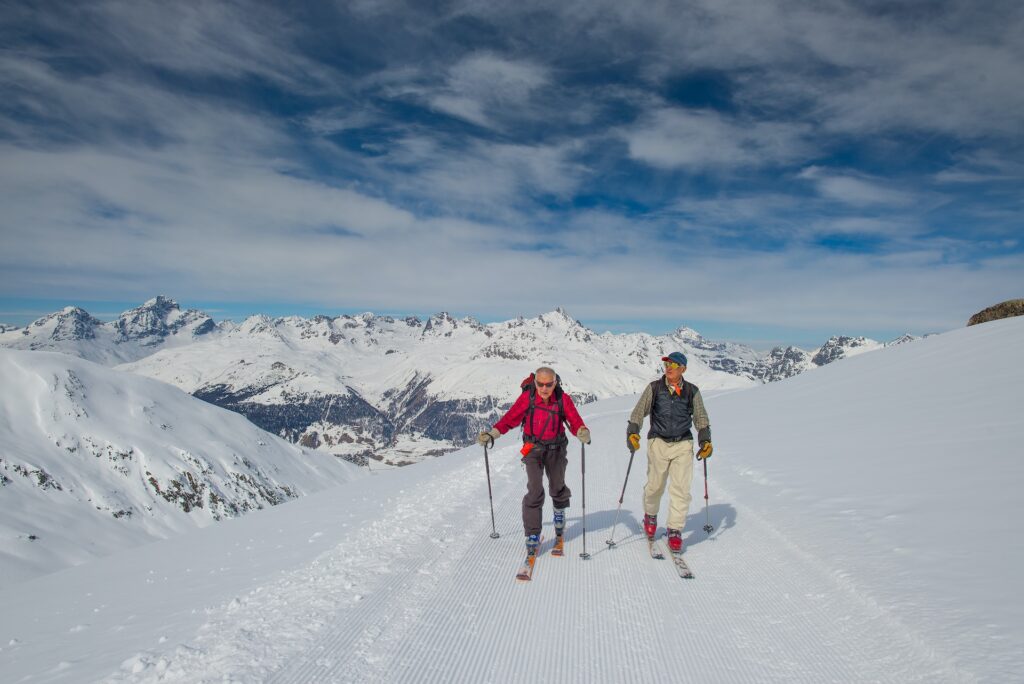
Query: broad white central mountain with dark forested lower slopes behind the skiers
119 310 756 464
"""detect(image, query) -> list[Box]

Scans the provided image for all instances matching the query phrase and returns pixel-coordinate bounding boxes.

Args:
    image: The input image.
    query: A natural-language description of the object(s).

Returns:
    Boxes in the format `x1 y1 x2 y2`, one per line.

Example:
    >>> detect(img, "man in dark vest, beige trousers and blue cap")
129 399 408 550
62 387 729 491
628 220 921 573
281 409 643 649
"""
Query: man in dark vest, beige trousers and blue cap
626 351 713 553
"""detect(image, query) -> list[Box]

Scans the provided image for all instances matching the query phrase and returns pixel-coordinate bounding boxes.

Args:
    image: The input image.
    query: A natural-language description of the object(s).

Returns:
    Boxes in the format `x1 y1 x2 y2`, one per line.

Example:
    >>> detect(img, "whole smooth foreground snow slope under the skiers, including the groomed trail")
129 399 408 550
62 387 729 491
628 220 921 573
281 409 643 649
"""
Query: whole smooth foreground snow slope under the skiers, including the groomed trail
0 318 1024 682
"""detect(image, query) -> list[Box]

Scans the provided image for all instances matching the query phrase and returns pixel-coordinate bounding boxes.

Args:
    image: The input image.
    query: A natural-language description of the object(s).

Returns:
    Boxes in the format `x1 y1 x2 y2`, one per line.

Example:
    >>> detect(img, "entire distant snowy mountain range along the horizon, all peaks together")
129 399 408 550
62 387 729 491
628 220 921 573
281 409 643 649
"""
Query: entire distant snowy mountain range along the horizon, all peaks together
0 297 905 465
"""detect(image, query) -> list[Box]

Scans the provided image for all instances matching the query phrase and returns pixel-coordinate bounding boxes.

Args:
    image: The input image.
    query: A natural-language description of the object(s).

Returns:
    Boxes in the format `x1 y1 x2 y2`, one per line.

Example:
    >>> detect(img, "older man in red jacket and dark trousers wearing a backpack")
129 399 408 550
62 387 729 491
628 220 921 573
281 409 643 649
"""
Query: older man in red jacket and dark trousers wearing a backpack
478 367 590 557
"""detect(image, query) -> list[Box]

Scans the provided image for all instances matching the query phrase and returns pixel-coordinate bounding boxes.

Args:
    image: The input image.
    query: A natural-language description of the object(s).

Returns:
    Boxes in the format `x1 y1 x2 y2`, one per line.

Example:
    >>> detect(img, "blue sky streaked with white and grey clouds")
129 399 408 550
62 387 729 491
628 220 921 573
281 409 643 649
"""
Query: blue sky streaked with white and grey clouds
0 0 1024 348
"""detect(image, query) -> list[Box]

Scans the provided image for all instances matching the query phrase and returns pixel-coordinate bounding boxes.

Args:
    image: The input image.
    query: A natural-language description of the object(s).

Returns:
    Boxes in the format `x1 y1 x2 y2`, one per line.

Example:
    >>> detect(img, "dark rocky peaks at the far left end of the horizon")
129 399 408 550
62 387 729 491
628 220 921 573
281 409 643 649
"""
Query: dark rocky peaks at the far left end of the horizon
0 296 218 366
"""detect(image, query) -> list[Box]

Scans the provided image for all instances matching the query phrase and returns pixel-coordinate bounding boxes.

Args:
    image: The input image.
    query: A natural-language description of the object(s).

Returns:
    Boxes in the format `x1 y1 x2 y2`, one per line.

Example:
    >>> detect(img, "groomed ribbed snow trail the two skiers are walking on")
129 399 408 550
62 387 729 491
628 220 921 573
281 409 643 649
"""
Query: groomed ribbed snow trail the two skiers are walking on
111 400 967 684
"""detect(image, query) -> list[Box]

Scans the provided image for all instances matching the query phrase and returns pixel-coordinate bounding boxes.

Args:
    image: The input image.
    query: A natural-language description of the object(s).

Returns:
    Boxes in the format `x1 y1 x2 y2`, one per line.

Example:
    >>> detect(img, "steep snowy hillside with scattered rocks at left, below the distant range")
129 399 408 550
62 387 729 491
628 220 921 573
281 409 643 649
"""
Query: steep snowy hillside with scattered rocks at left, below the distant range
0 349 360 583
